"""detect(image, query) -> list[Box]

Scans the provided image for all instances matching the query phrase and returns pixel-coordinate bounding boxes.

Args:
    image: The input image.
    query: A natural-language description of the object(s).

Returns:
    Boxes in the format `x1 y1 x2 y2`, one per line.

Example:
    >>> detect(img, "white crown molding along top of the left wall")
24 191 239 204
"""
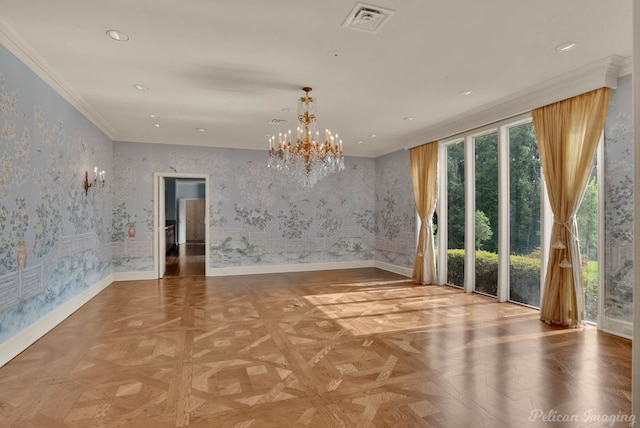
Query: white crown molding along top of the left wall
0 13 116 140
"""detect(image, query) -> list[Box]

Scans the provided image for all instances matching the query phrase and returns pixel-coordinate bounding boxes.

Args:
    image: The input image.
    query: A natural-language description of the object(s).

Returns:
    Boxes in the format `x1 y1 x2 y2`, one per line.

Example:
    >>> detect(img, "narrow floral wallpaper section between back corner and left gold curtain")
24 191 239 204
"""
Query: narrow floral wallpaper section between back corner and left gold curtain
372 150 416 268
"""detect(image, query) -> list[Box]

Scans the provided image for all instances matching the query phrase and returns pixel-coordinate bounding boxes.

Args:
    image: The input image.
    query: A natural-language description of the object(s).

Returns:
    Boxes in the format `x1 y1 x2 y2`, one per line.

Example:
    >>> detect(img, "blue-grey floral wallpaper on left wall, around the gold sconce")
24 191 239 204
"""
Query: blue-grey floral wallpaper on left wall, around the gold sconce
0 46 113 343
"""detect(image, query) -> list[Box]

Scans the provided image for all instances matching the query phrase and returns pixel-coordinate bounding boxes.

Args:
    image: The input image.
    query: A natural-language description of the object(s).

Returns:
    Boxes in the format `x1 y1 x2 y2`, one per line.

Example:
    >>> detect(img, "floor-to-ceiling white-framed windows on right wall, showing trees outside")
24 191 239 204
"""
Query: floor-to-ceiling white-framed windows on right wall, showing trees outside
439 116 602 322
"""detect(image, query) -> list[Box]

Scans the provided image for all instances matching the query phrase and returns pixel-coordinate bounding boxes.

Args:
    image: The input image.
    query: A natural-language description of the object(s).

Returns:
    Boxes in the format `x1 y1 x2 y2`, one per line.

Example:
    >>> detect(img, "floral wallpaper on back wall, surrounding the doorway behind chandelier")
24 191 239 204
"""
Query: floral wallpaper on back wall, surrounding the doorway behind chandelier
111 142 375 272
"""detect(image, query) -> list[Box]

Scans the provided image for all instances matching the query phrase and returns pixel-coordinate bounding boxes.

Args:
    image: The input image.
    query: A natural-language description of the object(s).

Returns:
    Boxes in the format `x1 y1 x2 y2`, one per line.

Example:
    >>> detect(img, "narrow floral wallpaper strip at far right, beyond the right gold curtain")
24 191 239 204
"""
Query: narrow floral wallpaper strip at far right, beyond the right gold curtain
604 75 633 323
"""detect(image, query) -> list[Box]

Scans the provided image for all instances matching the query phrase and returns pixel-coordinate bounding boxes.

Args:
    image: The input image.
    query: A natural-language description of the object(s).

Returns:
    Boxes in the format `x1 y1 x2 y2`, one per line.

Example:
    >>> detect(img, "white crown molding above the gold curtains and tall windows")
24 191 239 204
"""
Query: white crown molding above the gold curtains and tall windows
376 55 625 156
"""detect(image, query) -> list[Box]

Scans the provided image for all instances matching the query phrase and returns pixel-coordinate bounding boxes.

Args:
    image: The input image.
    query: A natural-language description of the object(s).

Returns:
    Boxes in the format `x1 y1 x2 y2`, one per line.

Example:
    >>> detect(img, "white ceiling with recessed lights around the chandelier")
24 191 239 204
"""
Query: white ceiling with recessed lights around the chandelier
0 0 632 156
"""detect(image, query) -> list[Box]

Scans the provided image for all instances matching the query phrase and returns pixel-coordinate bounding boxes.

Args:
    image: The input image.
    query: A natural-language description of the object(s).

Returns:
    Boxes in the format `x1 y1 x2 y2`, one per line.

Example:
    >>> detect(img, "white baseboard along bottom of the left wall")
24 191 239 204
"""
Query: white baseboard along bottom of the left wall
0 274 113 367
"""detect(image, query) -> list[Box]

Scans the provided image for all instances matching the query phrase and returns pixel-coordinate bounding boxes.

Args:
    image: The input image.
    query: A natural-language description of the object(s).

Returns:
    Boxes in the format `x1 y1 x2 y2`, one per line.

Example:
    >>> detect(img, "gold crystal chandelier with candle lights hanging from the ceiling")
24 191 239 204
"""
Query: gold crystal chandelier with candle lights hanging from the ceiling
269 87 344 187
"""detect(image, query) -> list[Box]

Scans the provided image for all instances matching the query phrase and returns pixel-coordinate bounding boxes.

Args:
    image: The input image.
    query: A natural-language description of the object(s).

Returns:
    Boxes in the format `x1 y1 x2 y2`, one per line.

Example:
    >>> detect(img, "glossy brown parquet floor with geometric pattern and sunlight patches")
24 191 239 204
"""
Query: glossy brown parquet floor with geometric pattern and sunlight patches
0 268 631 428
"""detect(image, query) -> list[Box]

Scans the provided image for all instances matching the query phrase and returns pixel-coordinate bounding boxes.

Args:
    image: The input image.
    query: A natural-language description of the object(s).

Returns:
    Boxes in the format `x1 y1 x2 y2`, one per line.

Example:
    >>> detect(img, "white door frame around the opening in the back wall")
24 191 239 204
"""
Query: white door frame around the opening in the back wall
153 172 211 278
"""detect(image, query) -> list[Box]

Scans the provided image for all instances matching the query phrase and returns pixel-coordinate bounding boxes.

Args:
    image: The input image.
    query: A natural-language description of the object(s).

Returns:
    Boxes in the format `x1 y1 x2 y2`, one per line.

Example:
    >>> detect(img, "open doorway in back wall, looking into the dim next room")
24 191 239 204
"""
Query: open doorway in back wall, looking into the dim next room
154 173 209 278
